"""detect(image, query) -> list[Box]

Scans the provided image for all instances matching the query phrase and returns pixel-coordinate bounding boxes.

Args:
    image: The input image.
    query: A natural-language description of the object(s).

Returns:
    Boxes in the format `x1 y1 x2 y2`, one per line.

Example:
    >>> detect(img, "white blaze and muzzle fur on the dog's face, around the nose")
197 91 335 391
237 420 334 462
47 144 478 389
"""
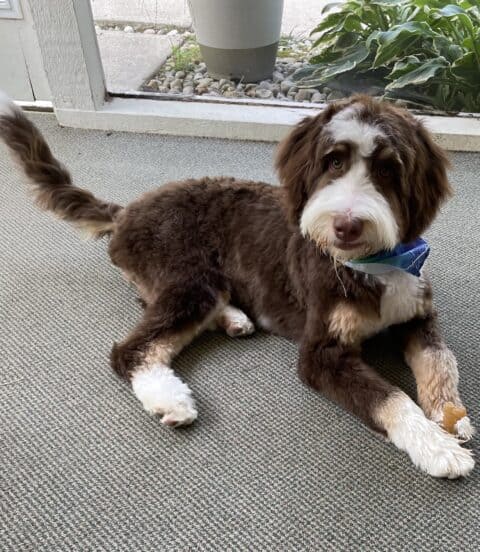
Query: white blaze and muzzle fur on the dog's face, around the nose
300 106 399 258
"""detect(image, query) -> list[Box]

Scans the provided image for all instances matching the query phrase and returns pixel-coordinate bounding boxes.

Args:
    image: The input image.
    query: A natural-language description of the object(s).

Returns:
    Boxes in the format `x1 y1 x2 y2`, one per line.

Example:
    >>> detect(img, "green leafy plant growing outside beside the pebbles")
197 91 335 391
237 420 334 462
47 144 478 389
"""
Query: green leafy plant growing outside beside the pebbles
294 0 480 112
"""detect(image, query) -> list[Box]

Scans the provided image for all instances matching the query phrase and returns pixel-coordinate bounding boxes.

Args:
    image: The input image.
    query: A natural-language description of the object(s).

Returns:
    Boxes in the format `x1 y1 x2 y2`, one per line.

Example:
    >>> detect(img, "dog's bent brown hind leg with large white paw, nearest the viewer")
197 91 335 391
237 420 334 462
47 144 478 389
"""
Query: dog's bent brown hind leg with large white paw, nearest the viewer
111 283 228 427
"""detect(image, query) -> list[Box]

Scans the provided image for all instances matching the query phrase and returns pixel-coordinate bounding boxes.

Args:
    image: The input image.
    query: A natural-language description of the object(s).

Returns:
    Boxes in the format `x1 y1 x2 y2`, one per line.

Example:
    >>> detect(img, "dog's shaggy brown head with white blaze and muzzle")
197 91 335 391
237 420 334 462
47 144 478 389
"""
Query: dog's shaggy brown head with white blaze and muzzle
277 97 450 260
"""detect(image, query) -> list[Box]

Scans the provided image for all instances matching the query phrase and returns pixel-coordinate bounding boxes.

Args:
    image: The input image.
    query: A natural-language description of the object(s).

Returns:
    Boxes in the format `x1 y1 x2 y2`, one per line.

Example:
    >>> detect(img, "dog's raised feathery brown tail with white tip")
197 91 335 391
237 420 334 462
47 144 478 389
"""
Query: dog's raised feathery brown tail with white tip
0 91 122 238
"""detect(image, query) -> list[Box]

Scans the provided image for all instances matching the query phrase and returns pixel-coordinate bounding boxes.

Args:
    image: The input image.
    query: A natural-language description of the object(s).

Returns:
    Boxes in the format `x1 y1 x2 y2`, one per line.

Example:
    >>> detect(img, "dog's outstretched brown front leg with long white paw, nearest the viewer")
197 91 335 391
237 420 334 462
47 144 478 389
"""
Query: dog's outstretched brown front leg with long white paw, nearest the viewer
299 339 474 479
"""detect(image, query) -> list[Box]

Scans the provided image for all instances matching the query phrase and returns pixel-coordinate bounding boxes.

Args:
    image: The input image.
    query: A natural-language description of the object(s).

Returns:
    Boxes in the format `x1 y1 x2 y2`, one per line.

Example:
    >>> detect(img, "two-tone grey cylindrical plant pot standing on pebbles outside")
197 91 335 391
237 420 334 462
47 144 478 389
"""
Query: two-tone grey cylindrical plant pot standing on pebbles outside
188 0 283 82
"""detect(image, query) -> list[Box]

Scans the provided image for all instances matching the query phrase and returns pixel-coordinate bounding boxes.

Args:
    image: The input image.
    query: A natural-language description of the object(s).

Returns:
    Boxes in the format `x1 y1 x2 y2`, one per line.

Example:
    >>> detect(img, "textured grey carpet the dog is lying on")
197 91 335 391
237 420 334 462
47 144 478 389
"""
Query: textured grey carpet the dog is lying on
0 115 480 551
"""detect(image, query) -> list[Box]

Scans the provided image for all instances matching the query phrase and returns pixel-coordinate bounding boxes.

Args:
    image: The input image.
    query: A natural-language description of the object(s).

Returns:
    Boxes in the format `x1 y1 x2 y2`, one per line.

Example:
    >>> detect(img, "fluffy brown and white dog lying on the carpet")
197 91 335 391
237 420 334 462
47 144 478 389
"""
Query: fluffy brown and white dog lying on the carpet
0 92 474 478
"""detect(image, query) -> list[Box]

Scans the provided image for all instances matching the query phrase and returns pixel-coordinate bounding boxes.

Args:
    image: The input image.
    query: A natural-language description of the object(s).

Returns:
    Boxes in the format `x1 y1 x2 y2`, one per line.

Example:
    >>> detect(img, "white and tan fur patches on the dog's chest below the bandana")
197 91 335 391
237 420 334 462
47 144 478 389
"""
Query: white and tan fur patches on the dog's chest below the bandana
329 270 430 344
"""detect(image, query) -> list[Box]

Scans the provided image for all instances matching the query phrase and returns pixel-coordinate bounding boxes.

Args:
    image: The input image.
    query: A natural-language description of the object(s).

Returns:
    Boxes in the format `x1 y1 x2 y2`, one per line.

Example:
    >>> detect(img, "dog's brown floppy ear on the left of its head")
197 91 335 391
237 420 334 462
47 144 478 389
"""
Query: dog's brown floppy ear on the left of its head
275 114 324 225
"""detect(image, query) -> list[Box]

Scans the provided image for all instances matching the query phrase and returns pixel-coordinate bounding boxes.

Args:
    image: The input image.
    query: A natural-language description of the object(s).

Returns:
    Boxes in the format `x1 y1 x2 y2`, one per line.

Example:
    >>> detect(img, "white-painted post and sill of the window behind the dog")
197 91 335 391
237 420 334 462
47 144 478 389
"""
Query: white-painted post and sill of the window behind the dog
30 0 480 151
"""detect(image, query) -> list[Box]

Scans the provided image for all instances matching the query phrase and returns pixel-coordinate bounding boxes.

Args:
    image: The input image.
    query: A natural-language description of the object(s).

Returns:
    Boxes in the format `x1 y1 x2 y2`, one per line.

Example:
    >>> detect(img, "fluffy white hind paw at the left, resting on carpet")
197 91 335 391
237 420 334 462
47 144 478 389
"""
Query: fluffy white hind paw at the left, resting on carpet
132 364 197 427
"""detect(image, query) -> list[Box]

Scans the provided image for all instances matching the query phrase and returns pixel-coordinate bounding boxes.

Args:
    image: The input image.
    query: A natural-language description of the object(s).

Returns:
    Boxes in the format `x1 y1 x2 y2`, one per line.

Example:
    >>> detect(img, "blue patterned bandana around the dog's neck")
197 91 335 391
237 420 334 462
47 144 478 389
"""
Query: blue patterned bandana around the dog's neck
345 238 430 277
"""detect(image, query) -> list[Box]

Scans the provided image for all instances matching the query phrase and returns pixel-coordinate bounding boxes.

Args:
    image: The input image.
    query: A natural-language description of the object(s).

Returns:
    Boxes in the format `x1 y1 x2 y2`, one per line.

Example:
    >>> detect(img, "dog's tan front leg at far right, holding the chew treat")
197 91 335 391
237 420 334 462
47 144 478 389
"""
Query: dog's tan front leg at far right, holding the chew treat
398 315 474 440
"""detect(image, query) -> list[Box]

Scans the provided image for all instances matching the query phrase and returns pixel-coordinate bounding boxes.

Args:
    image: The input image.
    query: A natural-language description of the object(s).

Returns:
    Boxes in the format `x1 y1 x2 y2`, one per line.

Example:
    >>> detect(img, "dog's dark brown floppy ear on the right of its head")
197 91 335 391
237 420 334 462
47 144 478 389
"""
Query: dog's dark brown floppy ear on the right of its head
405 122 453 242
